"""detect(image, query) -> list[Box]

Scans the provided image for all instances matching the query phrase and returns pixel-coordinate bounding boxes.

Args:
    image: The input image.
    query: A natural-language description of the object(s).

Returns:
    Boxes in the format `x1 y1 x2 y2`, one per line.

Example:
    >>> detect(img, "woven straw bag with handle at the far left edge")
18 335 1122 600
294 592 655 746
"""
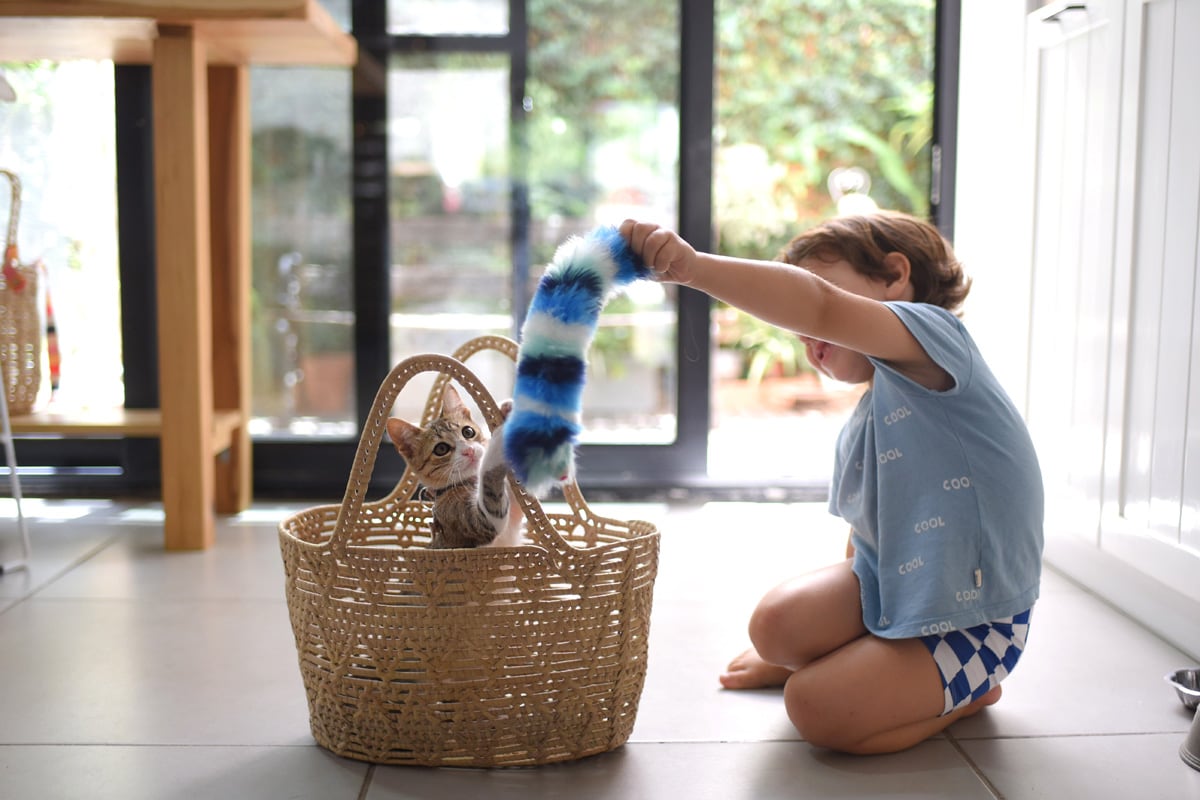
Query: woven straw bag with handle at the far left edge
0 169 42 414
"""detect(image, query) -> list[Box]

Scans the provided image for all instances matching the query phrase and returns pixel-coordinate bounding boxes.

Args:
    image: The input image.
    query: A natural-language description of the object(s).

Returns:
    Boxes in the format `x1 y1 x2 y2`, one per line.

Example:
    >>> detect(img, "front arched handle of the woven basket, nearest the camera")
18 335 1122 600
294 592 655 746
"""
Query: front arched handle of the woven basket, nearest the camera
329 354 574 559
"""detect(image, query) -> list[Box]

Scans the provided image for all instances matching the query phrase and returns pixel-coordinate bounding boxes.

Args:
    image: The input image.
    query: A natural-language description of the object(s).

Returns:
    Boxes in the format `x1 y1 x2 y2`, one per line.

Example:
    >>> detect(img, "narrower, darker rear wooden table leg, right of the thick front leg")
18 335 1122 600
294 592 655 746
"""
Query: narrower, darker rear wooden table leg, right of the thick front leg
209 66 252 513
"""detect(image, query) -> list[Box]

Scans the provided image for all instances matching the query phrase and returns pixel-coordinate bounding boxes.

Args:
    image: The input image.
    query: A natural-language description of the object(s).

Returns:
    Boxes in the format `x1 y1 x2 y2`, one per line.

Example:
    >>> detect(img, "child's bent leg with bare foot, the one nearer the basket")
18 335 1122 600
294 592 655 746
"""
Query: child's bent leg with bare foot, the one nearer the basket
721 561 866 688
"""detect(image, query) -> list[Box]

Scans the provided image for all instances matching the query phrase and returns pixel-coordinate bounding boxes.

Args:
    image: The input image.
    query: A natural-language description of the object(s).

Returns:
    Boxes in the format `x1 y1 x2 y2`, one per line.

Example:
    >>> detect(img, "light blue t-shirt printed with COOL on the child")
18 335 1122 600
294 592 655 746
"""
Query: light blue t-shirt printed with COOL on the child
829 302 1043 638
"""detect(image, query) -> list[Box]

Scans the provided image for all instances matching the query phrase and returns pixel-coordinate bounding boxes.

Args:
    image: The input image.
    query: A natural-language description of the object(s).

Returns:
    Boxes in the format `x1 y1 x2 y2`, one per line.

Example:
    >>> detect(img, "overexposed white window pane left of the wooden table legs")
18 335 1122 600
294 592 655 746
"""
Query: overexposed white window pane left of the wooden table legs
0 61 125 411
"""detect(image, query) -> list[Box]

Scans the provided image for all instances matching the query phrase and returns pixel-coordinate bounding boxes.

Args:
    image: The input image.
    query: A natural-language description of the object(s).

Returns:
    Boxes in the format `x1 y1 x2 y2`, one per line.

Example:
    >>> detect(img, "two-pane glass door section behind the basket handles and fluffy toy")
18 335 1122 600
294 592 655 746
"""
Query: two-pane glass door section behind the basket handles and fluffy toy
374 0 703 494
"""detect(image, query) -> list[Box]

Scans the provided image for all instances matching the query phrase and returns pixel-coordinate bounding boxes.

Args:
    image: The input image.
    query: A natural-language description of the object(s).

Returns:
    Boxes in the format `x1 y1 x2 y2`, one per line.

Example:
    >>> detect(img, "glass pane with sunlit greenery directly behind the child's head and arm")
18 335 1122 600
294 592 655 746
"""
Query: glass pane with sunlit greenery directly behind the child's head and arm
709 0 935 483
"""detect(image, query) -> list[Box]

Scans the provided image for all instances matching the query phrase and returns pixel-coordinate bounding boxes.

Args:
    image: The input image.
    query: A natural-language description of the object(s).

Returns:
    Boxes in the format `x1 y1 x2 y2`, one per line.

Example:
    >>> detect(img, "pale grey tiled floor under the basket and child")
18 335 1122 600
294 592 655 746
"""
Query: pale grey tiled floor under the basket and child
0 500 1200 800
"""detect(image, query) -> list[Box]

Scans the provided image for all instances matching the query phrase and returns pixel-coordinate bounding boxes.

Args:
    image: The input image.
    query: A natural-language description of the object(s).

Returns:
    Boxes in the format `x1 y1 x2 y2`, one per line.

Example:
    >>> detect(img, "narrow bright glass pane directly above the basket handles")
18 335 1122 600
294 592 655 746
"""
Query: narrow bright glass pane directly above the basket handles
388 54 512 419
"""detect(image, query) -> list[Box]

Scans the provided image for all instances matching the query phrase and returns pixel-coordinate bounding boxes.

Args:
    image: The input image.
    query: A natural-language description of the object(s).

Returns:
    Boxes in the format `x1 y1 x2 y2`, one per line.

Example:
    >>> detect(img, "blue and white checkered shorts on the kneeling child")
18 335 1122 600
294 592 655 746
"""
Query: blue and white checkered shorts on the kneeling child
920 609 1033 716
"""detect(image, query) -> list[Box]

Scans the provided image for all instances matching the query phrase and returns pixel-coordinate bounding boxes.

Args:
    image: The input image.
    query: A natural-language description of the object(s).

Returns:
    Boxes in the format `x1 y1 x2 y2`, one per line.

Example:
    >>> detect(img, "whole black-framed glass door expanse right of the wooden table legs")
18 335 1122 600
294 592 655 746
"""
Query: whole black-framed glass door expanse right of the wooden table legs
236 0 956 497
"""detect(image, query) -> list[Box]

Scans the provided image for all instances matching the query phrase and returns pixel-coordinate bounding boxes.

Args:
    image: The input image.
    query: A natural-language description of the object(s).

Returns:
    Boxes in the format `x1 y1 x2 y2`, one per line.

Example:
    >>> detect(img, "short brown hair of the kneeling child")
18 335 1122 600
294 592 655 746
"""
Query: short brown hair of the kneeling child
779 211 971 313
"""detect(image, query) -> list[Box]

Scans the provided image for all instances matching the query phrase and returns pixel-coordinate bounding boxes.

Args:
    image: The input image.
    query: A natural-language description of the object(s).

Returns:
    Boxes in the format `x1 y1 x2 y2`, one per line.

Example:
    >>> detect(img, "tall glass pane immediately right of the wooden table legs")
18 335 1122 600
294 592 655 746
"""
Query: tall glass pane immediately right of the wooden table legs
251 67 358 437
